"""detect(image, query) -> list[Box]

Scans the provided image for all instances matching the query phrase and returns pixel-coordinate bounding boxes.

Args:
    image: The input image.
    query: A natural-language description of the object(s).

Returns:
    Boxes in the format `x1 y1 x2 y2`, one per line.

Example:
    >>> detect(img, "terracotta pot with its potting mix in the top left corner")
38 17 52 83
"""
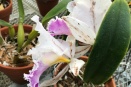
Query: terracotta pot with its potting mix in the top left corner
0 0 12 22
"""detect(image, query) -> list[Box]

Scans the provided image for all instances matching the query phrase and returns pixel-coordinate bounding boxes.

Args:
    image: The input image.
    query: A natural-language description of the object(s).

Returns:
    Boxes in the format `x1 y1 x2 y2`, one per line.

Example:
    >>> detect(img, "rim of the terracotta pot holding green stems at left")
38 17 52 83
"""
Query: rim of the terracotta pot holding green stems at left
0 24 33 70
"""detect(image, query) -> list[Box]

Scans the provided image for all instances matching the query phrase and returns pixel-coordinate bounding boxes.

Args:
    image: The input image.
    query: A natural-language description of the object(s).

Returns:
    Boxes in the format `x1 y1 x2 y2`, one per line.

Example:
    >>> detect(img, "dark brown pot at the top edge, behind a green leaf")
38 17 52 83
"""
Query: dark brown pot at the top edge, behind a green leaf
36 0 59 16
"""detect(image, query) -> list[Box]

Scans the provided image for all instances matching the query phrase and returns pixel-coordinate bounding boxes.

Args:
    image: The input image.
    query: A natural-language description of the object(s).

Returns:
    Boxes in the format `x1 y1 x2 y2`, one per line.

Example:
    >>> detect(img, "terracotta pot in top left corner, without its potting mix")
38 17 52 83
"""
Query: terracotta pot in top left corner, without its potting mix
0 0 12 22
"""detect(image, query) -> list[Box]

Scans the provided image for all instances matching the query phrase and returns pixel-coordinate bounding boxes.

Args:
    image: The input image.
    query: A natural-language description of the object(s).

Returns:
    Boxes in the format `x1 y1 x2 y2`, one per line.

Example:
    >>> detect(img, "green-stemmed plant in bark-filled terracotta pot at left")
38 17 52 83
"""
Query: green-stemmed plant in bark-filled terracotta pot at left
0 0 38 84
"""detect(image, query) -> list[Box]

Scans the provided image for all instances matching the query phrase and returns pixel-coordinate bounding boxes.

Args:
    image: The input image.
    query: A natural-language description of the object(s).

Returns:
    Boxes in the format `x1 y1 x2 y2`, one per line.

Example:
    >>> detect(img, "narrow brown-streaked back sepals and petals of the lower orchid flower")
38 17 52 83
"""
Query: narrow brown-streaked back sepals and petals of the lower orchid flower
40 36 90 87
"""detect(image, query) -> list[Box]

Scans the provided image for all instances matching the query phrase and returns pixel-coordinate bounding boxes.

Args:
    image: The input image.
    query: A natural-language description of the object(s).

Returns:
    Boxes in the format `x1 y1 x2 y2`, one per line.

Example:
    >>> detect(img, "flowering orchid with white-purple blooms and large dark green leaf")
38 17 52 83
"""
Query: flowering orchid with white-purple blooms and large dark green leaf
24 0 131 87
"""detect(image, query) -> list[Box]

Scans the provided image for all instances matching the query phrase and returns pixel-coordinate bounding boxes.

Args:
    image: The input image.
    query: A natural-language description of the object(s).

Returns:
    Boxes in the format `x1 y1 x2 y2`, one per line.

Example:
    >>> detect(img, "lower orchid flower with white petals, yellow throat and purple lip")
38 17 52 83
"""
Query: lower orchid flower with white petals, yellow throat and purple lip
24 16 89 87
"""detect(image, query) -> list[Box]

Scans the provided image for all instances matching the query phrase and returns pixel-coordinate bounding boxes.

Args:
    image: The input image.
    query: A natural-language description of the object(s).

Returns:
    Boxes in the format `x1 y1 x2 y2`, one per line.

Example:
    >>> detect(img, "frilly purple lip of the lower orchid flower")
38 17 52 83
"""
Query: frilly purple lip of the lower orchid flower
24 61 49 87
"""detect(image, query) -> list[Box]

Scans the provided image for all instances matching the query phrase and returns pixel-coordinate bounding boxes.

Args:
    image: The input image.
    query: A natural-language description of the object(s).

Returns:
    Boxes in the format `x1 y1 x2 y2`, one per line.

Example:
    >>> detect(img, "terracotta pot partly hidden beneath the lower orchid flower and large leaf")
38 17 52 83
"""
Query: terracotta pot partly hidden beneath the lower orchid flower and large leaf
54 56 116 87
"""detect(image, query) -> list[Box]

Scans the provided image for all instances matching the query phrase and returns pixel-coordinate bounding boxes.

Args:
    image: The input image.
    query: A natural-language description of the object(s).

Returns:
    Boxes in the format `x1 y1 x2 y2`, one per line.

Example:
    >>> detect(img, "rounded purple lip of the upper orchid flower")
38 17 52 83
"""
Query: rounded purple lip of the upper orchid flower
47 18 71 36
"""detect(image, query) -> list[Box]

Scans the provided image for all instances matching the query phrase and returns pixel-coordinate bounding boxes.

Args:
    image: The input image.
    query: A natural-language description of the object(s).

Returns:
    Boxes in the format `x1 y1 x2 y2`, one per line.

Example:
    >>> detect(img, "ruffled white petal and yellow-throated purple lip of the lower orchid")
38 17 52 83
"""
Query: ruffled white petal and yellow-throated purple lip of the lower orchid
24 16 70 87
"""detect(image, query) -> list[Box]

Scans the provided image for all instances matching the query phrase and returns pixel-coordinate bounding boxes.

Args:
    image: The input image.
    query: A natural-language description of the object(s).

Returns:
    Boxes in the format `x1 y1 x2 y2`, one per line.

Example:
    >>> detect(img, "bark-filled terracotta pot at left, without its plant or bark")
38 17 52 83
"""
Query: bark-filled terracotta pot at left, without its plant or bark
0 25 33 84
